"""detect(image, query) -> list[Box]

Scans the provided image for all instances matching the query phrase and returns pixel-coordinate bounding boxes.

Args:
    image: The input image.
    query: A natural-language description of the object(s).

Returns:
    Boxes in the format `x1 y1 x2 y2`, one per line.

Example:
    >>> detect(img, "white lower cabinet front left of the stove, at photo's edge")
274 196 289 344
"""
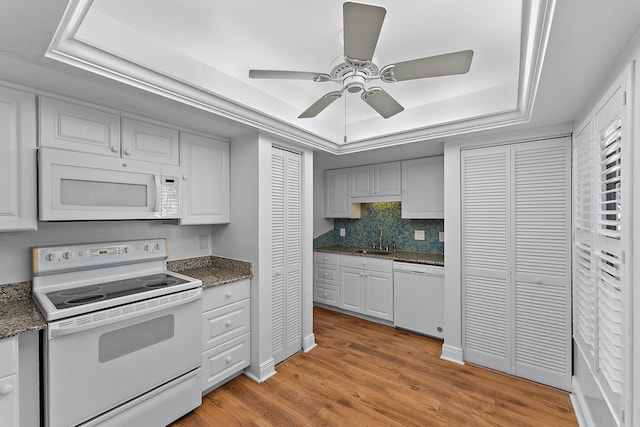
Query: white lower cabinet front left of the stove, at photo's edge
0 337 20 427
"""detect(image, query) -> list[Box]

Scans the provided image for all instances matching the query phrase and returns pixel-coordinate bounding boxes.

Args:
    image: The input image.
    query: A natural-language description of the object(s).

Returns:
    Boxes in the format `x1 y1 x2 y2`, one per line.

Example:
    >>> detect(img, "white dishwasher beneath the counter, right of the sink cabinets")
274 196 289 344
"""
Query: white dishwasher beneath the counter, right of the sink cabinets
393 261 444 338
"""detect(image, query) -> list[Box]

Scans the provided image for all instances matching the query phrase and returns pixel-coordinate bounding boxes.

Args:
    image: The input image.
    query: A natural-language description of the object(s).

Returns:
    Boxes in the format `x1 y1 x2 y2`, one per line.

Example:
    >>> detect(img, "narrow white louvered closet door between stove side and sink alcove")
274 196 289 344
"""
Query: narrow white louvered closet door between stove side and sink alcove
271 147 302 363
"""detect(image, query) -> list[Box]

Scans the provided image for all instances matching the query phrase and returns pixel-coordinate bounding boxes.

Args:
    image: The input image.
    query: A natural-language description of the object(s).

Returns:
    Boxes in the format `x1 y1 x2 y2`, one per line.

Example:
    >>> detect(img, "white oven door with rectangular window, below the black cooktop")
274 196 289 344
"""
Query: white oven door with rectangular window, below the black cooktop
44 288 202 427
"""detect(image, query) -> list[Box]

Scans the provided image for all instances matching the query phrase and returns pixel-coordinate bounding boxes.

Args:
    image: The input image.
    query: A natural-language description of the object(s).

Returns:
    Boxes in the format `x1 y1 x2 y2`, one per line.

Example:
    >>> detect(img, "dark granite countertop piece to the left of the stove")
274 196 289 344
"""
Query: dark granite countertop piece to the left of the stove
0 282 47 339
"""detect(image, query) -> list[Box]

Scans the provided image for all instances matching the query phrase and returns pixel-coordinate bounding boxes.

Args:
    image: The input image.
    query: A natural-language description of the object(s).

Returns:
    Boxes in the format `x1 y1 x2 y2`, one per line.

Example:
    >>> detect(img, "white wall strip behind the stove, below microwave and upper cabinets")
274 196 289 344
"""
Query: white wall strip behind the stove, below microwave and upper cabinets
0 220 211 284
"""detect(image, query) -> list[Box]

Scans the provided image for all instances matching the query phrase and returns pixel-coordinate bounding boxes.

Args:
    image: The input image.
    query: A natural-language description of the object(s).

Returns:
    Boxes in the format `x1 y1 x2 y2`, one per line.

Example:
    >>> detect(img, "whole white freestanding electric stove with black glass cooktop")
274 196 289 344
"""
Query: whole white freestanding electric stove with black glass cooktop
32 239 202 427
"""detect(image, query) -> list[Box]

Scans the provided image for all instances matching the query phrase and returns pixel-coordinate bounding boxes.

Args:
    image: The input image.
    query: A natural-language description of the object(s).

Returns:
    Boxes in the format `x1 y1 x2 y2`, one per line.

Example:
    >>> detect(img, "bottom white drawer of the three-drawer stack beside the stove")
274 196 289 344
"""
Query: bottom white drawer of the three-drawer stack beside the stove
202 333 251 391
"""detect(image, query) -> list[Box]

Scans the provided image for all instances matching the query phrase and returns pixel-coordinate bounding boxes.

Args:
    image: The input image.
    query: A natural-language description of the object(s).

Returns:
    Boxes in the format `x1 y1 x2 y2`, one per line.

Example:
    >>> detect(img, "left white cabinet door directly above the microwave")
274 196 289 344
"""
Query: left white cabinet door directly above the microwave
39 96 120 157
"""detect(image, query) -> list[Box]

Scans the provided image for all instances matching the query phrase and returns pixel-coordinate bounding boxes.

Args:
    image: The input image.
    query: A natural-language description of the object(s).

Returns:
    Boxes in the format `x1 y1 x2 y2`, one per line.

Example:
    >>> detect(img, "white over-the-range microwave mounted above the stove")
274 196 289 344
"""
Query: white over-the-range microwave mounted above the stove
38 148 181 221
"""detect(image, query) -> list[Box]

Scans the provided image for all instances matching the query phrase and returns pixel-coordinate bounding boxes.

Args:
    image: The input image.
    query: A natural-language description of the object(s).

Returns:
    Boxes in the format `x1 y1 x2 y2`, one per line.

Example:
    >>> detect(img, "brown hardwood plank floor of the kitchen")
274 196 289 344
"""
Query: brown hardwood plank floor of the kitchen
173 307 577 427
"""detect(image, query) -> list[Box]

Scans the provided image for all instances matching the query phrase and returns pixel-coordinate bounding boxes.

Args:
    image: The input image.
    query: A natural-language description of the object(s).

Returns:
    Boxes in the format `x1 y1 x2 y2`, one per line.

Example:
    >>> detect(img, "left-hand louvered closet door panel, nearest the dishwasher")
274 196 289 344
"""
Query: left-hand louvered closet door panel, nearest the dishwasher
461 146 512 372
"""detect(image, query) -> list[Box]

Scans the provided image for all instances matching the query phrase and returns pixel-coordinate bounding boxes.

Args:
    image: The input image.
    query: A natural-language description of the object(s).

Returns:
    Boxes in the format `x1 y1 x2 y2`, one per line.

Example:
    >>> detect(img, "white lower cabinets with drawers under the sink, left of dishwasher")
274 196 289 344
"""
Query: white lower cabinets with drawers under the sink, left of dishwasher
313 252 393 321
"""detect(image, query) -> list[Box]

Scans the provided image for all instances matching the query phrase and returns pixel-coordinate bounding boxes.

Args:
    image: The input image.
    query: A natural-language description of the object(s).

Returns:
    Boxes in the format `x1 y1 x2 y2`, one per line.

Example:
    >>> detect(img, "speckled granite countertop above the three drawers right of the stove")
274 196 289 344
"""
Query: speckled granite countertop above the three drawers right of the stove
167 256 253 288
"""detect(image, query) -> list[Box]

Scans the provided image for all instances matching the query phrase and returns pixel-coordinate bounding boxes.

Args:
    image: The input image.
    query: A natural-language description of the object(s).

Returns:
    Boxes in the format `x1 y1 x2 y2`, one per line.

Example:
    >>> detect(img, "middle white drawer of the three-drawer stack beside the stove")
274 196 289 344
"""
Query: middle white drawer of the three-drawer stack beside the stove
202 298 251 351
